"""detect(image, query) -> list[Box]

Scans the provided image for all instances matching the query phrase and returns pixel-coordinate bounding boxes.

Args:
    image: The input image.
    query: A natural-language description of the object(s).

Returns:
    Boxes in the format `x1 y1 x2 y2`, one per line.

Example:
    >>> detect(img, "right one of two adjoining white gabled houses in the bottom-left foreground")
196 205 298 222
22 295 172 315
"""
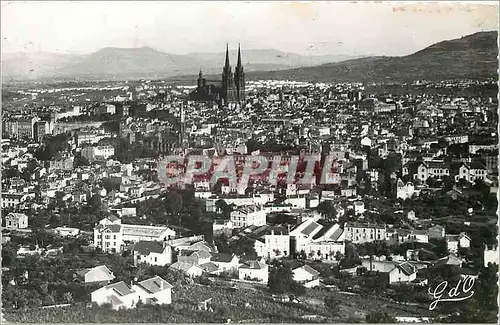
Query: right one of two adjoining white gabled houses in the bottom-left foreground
132 276 173 305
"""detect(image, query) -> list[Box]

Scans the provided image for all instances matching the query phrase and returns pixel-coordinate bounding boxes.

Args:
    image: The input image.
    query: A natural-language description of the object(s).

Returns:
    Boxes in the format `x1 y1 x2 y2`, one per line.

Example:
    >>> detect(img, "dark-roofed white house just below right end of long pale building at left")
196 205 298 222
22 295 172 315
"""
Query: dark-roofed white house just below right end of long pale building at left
132 241 172 266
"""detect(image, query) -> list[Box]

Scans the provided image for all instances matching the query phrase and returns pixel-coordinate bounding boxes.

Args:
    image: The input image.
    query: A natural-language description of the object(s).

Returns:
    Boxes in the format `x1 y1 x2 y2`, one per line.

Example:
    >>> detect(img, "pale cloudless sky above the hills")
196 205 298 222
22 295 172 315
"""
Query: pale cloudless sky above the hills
1 1 499 56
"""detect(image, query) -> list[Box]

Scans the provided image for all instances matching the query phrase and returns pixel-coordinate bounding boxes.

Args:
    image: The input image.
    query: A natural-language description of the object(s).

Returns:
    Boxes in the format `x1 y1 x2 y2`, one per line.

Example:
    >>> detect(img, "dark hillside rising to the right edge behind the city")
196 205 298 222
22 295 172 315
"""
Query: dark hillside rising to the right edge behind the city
242 31 498 82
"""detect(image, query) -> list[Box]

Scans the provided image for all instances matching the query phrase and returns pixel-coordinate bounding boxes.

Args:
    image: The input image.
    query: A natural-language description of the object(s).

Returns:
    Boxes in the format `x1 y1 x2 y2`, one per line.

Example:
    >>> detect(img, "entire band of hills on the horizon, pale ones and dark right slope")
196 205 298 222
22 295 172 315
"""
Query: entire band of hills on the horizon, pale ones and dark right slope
2 31 498 83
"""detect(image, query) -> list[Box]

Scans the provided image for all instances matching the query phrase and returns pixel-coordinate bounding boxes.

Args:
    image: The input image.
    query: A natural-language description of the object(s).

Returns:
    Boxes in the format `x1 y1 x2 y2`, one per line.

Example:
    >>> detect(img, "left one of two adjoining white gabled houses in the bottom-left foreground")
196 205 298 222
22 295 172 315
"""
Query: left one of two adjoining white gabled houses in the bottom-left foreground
90 281 139 310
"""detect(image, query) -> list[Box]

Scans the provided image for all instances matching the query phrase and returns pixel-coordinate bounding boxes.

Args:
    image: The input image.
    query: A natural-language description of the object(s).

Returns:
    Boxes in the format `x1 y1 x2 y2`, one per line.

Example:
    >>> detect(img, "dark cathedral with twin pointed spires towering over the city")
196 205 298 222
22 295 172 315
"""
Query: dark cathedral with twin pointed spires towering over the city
189 45 245 106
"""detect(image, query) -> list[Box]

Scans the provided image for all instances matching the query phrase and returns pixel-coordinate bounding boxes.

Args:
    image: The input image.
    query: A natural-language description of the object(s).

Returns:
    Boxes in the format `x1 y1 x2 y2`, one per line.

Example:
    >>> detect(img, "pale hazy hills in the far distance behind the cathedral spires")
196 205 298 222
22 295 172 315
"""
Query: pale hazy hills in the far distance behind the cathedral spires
2 47 366 81
